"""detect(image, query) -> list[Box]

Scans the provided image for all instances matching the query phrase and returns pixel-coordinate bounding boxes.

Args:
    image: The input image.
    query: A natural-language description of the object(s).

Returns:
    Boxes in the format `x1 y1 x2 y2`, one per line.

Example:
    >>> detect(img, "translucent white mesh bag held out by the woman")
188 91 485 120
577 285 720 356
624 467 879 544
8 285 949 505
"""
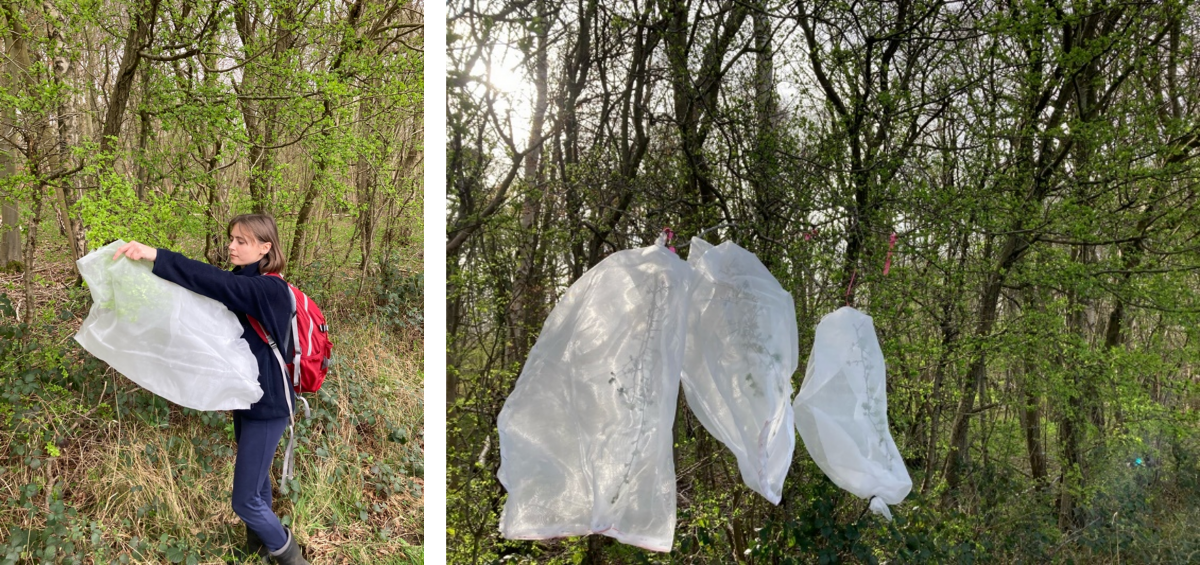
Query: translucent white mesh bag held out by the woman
74 240 263 410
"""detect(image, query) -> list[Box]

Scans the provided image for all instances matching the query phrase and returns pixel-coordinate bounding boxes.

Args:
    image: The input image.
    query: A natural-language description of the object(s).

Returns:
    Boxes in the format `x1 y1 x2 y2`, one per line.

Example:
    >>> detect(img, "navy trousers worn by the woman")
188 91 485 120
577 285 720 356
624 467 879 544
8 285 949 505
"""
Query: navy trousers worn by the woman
233 411 288 552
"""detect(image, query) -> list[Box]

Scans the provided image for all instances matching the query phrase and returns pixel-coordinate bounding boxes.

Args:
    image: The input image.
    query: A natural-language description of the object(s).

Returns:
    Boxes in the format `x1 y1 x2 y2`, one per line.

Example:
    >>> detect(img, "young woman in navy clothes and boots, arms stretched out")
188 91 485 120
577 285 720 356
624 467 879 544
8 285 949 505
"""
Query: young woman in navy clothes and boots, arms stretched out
113 214 308 565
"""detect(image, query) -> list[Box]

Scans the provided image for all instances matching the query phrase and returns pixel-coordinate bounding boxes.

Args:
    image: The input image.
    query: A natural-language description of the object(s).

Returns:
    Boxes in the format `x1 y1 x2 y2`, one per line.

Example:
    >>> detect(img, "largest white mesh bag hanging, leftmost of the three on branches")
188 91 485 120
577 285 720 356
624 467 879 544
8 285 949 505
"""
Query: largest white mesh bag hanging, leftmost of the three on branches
497 238 692 552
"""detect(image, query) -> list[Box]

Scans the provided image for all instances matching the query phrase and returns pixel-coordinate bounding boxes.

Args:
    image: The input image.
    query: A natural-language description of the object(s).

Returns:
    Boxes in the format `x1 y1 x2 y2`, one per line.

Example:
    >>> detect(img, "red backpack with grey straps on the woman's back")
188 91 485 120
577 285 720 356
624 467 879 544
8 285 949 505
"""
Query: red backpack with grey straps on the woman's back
247 272 334 393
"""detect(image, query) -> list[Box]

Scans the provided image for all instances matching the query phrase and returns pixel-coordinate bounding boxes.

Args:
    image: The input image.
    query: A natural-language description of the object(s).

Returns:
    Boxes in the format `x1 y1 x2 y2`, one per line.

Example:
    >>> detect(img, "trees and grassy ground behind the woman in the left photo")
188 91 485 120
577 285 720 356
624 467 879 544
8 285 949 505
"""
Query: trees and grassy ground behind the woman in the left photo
0 0 425 564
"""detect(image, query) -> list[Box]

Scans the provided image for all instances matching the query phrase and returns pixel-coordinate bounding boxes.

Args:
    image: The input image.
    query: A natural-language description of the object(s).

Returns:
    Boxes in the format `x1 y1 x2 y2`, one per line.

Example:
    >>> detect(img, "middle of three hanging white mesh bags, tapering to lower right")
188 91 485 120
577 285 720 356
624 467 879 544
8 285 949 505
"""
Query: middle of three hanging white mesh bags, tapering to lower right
683 238 799 504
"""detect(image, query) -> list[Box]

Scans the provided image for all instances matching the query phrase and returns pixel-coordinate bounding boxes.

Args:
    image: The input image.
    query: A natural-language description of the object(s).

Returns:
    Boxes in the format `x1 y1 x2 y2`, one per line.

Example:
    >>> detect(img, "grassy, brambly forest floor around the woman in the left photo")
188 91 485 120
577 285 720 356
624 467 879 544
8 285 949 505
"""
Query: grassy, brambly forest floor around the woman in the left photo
0 222 425 564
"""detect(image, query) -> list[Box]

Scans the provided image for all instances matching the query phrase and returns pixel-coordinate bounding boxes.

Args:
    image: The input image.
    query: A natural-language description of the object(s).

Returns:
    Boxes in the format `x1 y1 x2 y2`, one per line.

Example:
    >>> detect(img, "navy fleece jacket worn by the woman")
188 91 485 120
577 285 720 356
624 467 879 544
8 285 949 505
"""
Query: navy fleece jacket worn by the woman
154 248 295 420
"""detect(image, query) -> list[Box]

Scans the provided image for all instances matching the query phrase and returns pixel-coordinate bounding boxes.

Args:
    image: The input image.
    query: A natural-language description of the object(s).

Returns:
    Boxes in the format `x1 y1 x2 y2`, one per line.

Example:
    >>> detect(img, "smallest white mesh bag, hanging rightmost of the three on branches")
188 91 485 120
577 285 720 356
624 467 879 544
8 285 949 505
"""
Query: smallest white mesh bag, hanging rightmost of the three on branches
794 306 912 519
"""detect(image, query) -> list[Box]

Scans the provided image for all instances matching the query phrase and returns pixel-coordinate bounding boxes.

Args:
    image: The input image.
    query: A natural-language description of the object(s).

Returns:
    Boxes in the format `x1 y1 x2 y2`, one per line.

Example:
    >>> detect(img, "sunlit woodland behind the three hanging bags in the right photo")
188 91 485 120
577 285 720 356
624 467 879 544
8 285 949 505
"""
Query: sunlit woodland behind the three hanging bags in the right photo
445 0 1200 564
